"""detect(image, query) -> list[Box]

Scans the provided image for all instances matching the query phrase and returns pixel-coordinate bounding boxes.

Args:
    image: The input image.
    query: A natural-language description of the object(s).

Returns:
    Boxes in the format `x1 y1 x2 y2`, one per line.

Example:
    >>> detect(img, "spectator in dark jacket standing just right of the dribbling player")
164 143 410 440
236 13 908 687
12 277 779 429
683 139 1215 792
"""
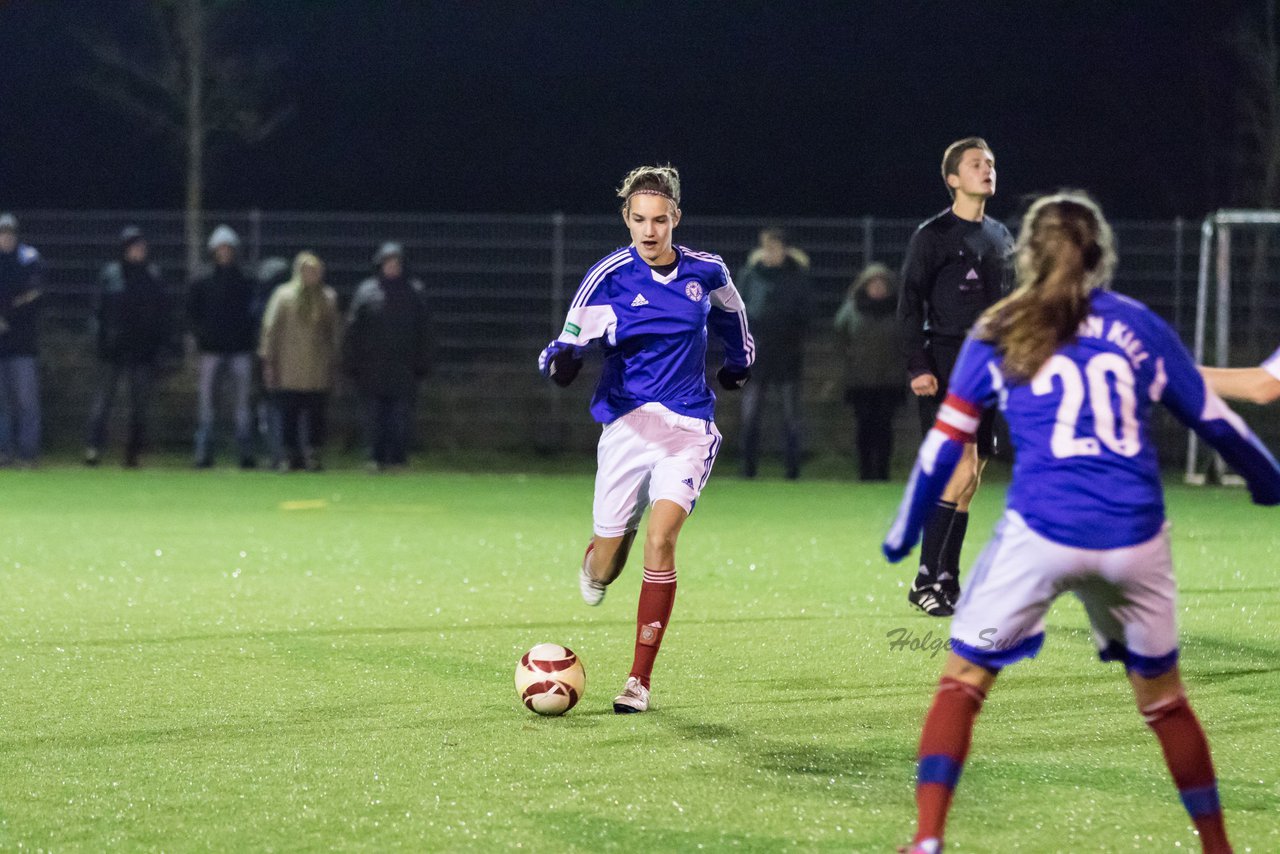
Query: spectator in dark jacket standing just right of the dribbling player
737 228 812 479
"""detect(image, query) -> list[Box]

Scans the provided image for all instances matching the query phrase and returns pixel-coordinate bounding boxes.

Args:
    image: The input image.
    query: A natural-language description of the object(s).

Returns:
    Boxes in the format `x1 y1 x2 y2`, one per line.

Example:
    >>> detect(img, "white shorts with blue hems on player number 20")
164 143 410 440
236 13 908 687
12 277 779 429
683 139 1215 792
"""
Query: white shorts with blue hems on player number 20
951 510 1178 679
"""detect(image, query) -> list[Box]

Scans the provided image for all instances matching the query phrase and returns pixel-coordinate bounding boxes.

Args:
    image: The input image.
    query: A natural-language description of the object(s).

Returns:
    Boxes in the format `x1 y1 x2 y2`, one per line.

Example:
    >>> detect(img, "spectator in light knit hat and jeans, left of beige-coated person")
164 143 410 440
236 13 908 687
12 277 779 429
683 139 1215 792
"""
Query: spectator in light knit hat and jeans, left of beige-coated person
187 225 259 469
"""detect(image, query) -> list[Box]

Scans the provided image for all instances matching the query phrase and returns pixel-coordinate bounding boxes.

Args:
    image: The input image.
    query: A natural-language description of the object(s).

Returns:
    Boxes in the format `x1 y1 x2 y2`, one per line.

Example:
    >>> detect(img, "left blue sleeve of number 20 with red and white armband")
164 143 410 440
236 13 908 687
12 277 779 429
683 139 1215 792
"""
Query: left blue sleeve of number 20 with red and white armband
881 338 996 563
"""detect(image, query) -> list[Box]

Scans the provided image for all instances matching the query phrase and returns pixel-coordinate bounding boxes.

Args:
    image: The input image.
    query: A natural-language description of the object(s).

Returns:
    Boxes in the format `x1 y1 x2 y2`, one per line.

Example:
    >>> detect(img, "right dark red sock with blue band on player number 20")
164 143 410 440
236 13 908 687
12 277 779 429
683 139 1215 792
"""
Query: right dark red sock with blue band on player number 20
1142 697 1231 854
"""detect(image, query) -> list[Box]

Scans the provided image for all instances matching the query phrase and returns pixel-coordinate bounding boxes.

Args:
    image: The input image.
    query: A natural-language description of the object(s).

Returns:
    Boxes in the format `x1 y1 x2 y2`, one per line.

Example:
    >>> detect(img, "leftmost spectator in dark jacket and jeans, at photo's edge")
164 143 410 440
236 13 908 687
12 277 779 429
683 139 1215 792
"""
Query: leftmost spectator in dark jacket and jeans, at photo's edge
0 214 42 466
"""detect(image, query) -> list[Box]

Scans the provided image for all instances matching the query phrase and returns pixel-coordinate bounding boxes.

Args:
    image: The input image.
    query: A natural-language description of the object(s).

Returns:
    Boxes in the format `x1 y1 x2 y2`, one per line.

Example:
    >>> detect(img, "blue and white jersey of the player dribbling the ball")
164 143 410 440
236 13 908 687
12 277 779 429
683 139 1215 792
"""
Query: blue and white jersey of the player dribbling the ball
559 246 755 424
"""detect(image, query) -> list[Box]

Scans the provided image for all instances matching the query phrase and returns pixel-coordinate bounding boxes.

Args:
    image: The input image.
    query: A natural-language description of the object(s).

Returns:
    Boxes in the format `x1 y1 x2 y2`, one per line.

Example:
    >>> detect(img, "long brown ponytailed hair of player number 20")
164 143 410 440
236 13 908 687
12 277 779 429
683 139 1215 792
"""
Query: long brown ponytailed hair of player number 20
975 189 1116 380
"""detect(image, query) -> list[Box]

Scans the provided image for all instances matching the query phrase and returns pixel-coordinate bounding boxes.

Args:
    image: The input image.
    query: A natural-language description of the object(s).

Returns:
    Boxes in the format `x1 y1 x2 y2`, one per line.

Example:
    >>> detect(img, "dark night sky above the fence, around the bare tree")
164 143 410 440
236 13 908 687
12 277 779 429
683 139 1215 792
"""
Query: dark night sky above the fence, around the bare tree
0 0 1244 219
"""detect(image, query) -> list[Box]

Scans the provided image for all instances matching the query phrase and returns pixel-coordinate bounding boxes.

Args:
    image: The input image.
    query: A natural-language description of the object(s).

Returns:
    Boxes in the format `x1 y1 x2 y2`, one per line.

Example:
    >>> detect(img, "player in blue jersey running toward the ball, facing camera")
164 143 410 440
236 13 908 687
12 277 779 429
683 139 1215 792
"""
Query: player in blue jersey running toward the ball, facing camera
538 165 755 714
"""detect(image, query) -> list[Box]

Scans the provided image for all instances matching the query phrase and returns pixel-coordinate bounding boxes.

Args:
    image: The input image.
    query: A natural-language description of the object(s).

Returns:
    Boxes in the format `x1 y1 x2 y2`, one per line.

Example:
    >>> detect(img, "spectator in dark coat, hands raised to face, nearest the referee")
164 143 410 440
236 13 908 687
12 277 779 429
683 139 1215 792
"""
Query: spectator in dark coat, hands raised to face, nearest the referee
835 264 906 480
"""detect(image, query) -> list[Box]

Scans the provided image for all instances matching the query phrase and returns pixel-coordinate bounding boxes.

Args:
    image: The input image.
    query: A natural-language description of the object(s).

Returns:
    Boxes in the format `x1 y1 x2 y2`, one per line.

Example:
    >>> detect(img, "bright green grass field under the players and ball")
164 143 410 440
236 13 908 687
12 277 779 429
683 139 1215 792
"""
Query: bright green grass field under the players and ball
0 467 1280 851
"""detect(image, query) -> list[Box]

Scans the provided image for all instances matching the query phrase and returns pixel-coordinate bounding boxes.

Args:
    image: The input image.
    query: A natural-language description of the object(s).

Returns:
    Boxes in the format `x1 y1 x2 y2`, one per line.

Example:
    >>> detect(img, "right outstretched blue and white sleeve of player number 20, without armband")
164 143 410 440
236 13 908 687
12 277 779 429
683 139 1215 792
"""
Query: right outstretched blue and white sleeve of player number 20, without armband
1153 319 1280 504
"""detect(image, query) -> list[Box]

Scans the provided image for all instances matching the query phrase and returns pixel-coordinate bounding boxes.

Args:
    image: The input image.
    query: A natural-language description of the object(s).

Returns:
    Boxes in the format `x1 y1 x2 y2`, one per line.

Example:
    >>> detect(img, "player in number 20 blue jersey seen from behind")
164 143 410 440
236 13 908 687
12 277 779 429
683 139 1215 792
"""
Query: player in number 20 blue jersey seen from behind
884 192 1280 854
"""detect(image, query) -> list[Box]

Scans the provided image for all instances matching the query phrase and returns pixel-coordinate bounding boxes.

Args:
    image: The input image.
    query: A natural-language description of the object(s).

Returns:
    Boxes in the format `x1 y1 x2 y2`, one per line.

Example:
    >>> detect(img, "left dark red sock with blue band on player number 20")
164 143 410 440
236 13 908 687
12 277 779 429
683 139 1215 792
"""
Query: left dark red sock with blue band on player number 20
914 676 987 842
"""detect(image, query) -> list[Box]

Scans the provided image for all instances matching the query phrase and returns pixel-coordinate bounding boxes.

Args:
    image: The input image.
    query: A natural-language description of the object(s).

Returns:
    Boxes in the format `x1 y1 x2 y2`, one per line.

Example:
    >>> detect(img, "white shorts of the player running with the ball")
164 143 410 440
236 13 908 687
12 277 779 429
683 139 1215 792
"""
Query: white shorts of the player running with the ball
591 403 721 536
